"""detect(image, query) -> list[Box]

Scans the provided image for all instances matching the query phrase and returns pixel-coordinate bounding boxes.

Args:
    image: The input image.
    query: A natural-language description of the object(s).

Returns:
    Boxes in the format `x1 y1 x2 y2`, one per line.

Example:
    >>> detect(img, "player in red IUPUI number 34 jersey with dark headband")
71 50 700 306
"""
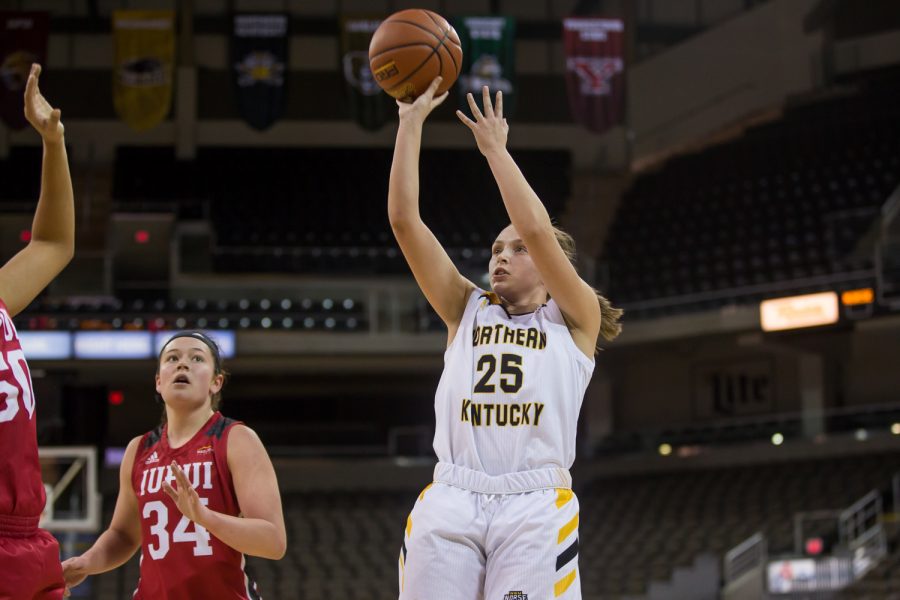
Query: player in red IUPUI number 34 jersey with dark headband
63 331 286 600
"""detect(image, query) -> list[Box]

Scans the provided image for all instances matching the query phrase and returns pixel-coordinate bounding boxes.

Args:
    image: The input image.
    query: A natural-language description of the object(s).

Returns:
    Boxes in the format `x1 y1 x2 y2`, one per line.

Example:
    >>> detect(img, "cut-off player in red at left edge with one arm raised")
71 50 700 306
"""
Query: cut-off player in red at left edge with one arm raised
0 64 75 600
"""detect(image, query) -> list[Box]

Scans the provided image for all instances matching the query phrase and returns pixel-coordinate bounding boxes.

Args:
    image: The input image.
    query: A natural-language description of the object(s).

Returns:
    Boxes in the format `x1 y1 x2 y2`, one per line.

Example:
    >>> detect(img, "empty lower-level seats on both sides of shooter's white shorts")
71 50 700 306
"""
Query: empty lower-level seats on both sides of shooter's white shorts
82 453 900 600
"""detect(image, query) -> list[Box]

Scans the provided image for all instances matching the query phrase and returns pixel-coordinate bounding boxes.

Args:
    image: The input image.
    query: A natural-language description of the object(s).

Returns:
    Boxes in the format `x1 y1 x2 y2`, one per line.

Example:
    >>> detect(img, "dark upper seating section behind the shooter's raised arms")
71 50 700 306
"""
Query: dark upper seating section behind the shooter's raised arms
114 147 570 274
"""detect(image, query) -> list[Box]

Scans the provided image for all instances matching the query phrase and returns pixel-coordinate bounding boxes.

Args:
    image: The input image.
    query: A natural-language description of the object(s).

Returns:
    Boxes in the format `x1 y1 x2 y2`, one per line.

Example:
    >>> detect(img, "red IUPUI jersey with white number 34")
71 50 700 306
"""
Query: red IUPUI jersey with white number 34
131 412 259 600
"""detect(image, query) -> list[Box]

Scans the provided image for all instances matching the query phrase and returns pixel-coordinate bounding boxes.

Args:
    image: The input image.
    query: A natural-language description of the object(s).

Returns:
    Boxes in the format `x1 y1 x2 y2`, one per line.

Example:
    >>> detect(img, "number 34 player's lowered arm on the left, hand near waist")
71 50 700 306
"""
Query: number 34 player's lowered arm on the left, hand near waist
62 437 141 595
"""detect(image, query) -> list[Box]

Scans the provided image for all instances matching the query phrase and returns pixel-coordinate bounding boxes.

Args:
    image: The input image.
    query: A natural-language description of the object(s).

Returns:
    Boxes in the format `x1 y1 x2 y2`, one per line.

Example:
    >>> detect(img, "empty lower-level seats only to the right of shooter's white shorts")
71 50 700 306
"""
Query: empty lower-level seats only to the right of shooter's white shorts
579 454 900 599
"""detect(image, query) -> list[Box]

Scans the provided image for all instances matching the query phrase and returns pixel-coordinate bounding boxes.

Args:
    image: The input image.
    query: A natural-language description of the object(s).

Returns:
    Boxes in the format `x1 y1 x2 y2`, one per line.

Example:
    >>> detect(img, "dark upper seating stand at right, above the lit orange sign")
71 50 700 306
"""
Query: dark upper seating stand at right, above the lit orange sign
602 69 900 318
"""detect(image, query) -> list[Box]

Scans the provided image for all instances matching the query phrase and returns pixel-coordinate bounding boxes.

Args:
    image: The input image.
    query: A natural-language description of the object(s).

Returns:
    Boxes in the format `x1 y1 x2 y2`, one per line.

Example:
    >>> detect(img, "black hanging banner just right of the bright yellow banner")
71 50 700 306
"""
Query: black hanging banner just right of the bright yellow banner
231 14 290 130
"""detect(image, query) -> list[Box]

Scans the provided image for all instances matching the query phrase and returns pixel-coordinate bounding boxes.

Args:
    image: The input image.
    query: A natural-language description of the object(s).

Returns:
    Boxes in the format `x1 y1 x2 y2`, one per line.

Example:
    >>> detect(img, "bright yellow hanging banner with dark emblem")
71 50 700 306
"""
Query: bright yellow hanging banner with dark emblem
113 10 175 131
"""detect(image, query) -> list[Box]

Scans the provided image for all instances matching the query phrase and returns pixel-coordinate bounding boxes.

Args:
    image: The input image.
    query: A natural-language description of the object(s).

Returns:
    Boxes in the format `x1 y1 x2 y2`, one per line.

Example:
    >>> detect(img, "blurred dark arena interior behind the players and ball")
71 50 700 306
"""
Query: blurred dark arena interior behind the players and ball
0 0 900 600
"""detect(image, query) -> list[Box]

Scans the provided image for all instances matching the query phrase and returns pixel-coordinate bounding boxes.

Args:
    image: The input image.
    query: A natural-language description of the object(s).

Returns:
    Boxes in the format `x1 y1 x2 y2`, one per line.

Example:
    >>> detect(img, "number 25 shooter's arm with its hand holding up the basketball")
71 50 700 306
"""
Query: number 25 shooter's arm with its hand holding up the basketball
388 78 475 340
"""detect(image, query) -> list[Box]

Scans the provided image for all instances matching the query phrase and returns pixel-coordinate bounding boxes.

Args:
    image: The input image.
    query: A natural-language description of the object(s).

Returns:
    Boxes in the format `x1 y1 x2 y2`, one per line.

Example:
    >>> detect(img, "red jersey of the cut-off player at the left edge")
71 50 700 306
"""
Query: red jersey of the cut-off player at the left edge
0 300 46 527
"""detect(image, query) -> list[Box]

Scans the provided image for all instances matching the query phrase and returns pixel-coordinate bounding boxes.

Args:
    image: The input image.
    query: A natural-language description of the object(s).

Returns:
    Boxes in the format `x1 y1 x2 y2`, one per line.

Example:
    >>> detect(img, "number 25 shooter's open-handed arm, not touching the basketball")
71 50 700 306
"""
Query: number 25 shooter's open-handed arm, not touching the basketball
456 86 600 356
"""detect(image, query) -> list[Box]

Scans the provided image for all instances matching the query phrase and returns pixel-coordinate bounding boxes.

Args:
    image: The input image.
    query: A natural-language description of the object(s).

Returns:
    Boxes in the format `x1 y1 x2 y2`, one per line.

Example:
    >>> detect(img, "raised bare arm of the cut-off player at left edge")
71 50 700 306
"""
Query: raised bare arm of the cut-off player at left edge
0 64 75 315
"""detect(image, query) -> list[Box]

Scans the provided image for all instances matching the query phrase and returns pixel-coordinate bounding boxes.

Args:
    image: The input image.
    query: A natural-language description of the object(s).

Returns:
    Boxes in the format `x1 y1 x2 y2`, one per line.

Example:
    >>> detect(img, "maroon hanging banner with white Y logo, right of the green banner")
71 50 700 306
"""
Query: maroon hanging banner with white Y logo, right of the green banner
563 17 625 133
